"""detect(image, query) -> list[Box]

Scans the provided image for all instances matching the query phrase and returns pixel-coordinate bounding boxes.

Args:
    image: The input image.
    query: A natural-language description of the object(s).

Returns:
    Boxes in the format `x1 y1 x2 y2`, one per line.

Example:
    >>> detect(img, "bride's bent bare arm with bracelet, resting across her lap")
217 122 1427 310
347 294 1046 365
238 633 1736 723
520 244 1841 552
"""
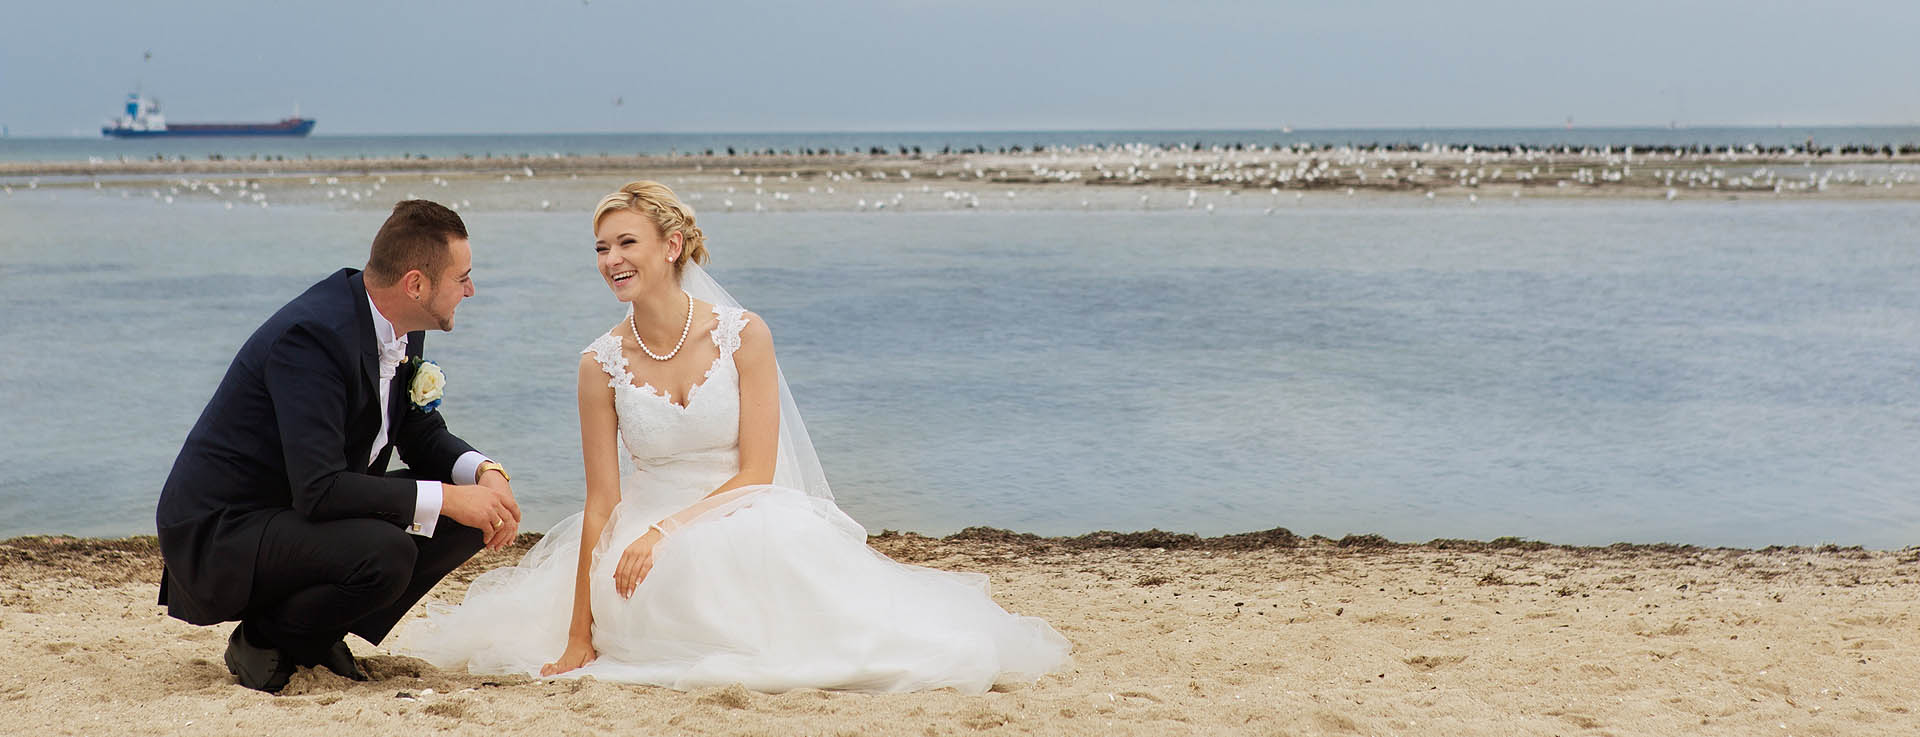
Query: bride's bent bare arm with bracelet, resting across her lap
612 313 780 597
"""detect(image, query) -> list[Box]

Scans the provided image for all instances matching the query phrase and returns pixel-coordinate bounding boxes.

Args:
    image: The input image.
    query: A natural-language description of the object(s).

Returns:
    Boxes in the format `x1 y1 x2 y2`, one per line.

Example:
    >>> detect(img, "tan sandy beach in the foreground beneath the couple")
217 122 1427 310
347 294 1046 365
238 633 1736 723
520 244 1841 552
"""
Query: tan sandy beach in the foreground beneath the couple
0 528 1920 737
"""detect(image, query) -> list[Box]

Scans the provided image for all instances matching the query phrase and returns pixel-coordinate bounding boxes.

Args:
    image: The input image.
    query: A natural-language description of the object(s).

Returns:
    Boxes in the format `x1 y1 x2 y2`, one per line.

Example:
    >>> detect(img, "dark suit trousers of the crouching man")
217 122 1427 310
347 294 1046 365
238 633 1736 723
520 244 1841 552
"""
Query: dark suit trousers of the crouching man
242 472 486 662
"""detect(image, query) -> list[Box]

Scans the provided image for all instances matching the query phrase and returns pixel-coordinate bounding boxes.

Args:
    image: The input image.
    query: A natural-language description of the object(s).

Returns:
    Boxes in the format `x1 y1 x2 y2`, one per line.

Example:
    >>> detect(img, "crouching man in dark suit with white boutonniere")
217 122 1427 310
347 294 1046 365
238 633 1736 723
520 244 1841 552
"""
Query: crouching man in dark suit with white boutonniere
156 200 520 691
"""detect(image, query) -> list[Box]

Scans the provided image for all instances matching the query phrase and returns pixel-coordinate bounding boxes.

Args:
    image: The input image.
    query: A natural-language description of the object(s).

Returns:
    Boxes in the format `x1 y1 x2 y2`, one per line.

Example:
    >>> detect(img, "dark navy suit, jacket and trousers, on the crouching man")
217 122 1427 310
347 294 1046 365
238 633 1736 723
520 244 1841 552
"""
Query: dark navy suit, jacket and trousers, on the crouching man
156 269 482 651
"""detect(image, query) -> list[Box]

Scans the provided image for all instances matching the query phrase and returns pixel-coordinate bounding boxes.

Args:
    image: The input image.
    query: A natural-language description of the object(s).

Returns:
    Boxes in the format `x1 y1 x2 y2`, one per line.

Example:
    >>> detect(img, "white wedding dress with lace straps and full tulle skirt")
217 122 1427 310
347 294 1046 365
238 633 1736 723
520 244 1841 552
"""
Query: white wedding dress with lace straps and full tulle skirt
401 307 1071 693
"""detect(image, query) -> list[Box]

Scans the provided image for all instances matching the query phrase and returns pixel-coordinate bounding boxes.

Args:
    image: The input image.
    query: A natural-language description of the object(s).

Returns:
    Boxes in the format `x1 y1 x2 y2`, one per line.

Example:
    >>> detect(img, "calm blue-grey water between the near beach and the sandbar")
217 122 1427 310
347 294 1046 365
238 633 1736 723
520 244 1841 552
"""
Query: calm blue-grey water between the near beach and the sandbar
0 188 1920 547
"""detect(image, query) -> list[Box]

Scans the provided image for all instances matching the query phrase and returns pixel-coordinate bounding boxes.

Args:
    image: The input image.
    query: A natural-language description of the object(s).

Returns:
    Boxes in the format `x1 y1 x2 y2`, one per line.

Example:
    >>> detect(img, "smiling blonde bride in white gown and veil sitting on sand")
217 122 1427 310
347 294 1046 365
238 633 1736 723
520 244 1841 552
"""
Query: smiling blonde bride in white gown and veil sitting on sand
405 180 1071 693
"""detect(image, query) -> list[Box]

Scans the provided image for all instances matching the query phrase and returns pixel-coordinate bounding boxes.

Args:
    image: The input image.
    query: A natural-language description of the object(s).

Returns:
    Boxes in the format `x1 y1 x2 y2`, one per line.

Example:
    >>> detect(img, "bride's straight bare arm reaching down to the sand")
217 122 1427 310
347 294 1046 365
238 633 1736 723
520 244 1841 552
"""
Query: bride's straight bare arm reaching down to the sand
540 355 620 676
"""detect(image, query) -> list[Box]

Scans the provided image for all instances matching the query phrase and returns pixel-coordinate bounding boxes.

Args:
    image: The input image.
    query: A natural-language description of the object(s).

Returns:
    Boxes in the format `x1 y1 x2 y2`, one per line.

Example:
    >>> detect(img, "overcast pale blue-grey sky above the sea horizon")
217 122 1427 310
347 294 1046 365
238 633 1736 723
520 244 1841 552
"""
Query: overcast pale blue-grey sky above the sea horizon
0 0 1920 136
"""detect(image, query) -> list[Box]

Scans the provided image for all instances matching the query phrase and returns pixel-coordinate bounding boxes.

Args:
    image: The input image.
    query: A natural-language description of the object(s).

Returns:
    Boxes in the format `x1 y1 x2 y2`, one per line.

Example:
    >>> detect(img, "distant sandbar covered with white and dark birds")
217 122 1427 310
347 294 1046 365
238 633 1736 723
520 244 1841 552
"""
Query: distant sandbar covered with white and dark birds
11 146 1920 213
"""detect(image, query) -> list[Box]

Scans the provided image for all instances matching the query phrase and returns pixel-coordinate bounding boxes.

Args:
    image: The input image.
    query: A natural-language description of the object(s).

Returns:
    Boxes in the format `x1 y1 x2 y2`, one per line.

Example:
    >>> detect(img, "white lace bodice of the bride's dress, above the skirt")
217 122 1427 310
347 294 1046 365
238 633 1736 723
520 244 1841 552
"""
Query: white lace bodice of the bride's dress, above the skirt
580 305 747 491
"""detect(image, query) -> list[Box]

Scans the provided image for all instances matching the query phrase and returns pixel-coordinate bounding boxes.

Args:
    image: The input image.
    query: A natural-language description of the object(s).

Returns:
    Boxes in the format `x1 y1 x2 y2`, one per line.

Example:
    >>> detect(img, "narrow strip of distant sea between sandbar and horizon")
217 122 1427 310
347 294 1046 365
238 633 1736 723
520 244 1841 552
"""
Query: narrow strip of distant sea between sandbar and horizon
11 121 1920 161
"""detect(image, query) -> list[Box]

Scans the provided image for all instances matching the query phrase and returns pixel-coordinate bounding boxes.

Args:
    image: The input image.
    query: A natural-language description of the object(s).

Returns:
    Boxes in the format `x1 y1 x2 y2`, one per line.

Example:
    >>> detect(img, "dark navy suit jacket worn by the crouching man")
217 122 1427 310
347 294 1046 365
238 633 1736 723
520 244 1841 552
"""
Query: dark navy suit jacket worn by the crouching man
156 269 472 624
